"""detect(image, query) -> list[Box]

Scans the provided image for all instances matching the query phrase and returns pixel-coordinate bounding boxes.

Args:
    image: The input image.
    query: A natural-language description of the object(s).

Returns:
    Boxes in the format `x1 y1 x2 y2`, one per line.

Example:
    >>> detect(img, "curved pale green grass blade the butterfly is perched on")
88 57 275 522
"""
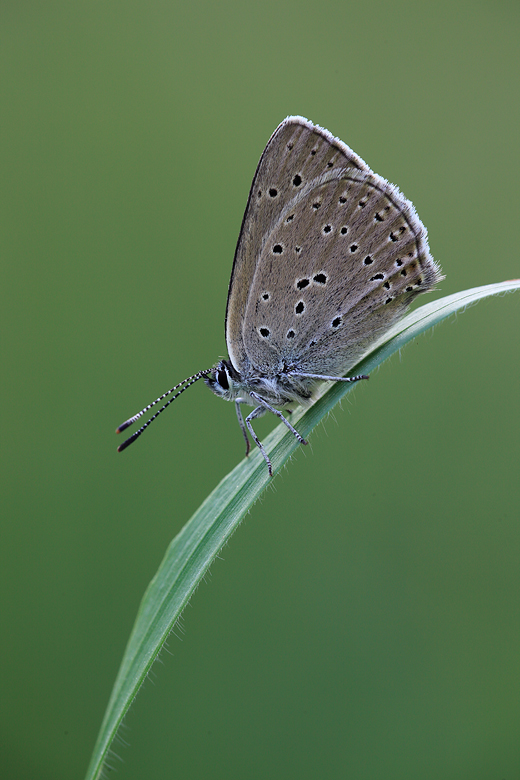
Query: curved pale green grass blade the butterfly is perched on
86 280 520 780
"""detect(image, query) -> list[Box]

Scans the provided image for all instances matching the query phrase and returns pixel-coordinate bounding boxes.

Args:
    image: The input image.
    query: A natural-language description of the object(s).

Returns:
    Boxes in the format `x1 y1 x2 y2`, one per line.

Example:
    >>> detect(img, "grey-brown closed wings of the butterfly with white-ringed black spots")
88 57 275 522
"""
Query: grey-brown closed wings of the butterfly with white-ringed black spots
226 117 440 376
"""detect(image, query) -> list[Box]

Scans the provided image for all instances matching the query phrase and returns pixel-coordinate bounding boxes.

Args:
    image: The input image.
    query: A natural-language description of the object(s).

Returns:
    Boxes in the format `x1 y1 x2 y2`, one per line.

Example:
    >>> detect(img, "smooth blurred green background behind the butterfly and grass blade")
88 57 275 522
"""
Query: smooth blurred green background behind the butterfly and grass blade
0 0 520 780
